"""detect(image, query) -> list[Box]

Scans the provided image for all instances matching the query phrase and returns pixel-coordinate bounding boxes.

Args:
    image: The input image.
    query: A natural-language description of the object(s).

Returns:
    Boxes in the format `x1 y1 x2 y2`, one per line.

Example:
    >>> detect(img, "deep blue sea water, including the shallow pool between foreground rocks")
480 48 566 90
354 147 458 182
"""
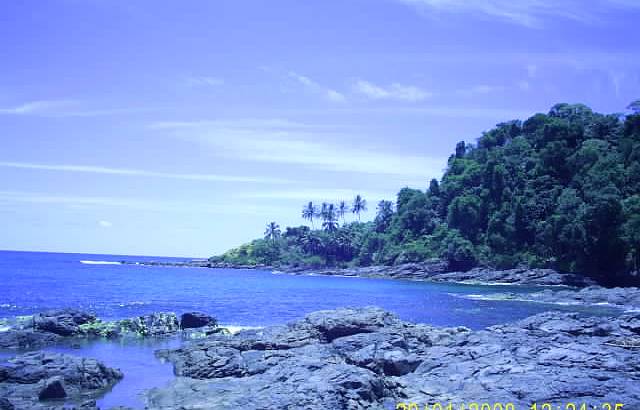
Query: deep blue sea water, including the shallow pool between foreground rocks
0 251 620 408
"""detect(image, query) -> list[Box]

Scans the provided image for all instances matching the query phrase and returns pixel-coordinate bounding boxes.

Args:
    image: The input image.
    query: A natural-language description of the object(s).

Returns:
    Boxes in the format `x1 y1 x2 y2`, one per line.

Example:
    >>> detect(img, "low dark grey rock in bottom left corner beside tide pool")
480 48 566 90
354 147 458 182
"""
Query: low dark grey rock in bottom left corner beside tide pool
0 352 123 409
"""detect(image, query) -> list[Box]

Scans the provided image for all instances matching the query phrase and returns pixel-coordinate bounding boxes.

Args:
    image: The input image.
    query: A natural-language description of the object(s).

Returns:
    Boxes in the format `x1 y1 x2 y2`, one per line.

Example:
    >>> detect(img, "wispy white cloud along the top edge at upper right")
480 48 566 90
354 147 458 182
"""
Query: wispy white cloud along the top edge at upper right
398 0 640 27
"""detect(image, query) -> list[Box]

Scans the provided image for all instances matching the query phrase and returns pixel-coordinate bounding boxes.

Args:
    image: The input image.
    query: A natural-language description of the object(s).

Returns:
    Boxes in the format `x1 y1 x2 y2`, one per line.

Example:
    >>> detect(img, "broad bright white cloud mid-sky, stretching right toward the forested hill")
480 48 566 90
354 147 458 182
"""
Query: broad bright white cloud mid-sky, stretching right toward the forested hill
153 120 445 180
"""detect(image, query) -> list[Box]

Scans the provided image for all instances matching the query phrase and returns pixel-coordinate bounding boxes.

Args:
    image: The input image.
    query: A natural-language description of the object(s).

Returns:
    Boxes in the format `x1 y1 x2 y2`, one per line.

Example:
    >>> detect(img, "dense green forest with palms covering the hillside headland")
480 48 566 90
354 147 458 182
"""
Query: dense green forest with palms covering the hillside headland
212 102 640 284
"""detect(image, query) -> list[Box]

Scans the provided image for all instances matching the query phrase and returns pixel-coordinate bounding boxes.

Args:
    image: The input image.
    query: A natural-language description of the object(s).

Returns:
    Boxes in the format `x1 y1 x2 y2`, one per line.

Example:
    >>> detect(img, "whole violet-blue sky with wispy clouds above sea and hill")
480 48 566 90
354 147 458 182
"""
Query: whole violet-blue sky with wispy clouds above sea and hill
0 0 640 257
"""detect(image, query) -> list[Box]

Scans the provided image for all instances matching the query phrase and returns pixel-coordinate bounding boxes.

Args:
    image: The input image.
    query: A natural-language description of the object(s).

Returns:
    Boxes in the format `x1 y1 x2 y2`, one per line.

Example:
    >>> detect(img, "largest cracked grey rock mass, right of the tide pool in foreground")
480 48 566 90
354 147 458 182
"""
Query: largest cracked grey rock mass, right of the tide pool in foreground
147 308 640 409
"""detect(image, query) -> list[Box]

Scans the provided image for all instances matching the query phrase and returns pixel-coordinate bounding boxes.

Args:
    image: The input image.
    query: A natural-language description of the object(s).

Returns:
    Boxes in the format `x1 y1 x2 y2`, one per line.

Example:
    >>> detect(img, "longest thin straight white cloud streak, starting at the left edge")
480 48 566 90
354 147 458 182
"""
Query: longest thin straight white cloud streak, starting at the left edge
0 161 292 184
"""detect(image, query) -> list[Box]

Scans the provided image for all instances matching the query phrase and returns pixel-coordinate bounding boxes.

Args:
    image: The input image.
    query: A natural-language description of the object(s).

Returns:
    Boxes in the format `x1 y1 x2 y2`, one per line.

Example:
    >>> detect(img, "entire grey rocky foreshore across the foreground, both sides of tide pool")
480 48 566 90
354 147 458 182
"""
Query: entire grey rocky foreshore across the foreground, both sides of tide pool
0 300 640 410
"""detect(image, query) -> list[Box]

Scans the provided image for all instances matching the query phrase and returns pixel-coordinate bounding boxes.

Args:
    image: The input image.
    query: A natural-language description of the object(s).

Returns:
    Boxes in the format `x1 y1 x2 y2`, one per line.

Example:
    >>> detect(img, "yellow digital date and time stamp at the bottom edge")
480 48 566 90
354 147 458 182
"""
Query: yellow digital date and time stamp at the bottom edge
396 402 624 410
